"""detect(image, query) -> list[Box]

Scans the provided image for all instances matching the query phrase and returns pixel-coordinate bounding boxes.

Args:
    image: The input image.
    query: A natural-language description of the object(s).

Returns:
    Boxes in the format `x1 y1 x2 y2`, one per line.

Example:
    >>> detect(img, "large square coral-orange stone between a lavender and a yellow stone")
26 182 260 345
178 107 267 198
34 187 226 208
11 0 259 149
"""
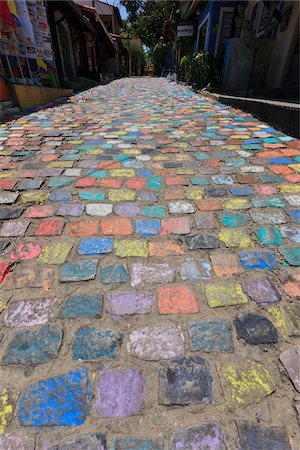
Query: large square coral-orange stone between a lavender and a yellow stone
158 286 199 314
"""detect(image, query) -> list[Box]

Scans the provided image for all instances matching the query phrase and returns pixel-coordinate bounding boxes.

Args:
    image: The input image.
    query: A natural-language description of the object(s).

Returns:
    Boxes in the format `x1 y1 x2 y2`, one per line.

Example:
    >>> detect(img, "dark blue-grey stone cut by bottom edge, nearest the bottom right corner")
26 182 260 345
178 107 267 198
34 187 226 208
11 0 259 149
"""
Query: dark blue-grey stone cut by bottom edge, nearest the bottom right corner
236 421 292 450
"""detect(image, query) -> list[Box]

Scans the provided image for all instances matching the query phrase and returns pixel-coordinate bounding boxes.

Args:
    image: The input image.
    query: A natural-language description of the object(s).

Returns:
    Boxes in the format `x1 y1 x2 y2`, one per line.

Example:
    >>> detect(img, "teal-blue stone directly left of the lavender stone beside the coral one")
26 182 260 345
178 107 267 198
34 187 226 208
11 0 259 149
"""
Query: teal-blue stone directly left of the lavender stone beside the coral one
59 294 103 318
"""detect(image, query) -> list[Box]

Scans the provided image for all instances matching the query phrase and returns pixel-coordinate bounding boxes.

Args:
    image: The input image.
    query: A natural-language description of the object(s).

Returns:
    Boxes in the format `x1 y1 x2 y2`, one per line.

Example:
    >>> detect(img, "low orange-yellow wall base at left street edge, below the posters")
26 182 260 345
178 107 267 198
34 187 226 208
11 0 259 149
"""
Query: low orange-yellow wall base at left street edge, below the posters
10 84 73 110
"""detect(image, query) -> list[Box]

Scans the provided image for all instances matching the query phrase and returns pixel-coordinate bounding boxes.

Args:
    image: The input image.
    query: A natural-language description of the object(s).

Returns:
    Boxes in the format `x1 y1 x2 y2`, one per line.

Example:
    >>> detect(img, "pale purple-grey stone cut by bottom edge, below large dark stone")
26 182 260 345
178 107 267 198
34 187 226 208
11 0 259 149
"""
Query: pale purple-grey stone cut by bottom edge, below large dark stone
169 422 227 450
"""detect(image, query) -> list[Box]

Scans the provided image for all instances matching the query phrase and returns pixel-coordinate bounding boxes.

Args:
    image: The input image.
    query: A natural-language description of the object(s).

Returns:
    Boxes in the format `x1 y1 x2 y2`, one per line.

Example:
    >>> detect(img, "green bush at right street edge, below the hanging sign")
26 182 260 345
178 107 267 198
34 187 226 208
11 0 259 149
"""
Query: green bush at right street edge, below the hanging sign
180 52 218 89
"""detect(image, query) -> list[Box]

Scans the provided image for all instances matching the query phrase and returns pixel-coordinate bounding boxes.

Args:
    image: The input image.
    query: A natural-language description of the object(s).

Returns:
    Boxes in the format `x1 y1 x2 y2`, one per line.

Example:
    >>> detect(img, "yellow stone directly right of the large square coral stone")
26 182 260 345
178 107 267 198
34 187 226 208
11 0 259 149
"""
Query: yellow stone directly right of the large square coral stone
205 284 248 308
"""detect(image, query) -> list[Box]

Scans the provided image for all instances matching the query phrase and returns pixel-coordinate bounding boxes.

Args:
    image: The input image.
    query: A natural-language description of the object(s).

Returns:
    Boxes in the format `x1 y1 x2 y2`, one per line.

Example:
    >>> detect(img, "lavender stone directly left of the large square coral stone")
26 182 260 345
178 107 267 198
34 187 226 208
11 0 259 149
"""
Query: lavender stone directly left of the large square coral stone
106 291 155 316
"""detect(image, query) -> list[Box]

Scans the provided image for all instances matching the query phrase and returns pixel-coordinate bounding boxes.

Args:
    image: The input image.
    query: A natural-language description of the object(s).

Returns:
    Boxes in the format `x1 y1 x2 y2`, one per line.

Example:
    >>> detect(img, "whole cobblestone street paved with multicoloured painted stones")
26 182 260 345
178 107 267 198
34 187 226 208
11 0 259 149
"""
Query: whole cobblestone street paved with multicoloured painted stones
0 78 300 450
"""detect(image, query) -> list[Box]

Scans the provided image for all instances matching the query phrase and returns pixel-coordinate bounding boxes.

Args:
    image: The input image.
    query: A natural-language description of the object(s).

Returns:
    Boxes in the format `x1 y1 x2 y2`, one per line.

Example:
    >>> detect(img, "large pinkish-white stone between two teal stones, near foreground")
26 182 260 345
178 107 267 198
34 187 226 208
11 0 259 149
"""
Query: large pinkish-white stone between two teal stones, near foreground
128 325 184 361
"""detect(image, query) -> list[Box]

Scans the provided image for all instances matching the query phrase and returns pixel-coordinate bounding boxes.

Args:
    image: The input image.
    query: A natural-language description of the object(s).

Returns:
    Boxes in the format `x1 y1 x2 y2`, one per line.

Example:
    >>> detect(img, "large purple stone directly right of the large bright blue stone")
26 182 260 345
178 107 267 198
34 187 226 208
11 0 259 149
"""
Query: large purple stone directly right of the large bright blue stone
96 369 144 417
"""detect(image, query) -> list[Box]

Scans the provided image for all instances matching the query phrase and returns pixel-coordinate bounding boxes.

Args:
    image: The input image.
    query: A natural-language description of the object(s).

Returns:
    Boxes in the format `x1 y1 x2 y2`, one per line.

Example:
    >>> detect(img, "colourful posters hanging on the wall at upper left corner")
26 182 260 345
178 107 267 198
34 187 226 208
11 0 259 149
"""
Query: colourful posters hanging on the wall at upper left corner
0 0 58 87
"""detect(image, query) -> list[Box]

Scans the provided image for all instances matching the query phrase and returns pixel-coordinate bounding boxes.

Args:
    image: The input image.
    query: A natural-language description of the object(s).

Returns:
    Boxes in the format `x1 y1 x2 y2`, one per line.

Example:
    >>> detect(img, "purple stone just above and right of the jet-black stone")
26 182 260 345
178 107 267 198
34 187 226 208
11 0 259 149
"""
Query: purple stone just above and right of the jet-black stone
243 277 281 303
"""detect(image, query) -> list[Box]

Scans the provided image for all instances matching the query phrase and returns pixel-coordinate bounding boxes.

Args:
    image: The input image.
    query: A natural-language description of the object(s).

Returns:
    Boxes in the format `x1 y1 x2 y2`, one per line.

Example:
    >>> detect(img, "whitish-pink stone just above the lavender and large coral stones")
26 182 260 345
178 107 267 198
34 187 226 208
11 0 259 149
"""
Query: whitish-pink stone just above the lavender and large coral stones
130 263 175 286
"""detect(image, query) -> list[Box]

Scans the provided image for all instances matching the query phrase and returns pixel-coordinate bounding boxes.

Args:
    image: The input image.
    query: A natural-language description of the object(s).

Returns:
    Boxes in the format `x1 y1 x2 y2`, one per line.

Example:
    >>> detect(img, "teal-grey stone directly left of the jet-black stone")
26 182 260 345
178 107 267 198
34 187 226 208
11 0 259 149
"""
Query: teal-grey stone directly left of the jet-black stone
188 319 233 353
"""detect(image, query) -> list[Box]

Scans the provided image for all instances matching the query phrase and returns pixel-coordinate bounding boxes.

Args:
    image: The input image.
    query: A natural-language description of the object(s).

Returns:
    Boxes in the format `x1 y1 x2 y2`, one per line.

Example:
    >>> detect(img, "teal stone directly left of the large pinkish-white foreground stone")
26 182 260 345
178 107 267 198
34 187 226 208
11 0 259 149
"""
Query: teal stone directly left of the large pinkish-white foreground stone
72 327 124 361
